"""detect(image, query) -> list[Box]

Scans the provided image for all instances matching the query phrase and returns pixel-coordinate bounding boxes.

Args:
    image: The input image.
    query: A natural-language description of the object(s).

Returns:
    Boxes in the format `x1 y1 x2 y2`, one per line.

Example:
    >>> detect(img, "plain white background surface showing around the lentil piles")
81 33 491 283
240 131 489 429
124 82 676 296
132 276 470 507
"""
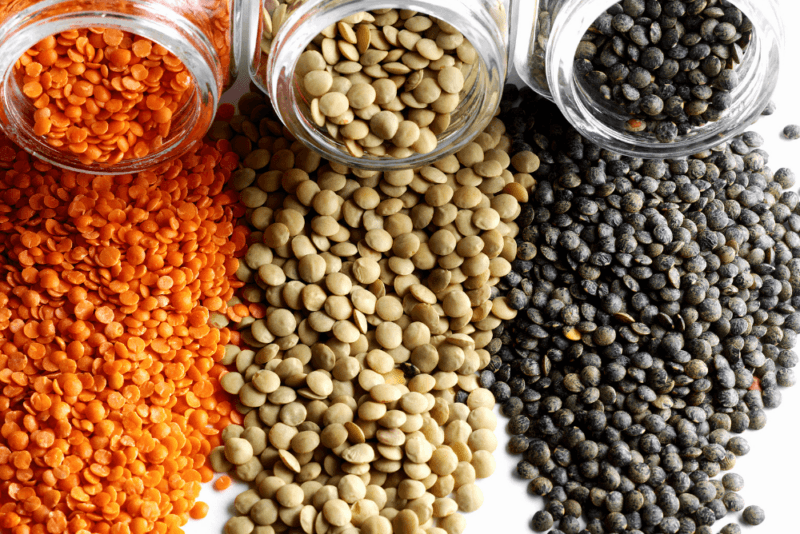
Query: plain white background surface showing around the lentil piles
197 0 800 534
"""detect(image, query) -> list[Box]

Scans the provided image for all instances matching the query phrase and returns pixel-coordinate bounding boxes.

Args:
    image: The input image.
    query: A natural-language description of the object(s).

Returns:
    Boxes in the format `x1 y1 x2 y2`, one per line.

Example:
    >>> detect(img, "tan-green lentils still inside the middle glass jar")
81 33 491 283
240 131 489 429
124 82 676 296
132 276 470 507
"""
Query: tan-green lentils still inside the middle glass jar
295 9 477 158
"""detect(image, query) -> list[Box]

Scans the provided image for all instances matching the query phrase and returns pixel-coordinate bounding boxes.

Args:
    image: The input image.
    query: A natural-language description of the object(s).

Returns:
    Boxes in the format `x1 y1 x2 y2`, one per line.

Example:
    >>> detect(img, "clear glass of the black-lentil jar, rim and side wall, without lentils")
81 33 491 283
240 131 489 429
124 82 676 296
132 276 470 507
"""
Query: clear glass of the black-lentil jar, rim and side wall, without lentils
512 0 784 158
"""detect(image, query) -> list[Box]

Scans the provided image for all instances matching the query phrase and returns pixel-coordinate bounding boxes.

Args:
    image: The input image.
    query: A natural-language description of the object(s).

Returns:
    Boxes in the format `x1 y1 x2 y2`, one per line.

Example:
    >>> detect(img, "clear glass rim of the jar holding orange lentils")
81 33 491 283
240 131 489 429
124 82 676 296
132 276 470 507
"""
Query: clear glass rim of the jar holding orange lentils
0 0 220 175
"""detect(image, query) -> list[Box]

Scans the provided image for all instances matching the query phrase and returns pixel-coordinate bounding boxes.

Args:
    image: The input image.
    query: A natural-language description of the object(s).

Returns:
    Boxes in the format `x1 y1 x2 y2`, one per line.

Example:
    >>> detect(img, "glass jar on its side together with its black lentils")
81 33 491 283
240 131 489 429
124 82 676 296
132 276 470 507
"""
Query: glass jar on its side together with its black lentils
512 0 784 158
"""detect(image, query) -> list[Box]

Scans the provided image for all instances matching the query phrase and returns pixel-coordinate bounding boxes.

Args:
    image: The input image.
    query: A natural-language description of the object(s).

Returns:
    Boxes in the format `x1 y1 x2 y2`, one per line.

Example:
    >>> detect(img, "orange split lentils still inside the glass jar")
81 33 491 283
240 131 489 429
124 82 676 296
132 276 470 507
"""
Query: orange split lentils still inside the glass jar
17 28 192 165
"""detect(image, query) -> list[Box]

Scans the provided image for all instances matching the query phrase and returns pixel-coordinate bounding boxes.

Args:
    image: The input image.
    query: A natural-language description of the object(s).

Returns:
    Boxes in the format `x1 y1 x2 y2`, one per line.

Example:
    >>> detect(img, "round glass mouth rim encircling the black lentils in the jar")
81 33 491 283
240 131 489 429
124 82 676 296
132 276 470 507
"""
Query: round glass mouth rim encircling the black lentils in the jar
547 0 783 158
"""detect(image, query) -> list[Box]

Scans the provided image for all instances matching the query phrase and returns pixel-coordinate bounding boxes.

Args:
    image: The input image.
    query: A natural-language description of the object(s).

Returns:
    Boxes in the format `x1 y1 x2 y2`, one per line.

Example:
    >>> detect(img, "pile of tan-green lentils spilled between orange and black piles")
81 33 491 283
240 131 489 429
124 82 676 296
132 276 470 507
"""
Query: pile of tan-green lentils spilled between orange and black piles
210 93 538 534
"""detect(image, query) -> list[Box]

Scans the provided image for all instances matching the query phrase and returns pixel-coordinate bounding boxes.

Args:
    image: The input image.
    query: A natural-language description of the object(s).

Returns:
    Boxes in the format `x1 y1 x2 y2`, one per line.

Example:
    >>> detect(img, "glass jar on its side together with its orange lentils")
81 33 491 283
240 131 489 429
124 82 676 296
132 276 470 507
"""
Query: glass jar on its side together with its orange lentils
0 0 240 174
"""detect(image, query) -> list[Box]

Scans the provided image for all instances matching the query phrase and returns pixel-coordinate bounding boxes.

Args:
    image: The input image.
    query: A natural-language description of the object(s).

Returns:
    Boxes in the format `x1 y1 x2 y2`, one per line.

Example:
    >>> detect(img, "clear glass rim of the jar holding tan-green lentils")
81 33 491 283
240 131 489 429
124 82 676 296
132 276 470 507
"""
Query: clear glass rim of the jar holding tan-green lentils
266 0 507 171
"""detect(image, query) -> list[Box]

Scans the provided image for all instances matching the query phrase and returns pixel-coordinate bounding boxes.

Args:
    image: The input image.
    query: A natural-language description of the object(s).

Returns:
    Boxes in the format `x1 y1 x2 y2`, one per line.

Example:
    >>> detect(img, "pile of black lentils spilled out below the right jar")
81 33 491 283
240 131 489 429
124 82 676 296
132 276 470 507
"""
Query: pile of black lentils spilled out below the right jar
480 82 800 534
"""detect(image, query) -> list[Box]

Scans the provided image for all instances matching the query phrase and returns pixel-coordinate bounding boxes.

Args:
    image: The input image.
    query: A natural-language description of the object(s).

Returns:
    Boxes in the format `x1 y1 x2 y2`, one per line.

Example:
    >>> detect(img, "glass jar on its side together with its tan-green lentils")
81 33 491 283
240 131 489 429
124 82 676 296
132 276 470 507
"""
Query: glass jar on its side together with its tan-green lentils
250 0 509 170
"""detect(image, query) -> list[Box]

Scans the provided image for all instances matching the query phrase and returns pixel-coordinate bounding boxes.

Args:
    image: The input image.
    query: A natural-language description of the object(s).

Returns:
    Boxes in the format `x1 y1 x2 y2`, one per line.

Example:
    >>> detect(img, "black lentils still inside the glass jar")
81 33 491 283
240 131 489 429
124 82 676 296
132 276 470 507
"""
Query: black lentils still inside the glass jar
575 0 753 142
